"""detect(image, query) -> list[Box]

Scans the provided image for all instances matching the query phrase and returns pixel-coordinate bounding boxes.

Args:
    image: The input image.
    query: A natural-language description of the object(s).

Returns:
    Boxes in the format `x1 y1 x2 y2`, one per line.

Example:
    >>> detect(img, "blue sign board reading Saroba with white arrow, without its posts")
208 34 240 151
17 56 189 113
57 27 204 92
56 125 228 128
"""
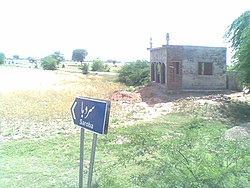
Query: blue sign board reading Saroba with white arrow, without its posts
71 97 110 134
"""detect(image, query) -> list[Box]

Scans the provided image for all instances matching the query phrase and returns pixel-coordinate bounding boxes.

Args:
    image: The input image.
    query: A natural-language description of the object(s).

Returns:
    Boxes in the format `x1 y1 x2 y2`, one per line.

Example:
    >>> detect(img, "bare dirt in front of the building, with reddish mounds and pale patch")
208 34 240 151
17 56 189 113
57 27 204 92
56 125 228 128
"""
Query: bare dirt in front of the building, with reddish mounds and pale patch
110 83 250 117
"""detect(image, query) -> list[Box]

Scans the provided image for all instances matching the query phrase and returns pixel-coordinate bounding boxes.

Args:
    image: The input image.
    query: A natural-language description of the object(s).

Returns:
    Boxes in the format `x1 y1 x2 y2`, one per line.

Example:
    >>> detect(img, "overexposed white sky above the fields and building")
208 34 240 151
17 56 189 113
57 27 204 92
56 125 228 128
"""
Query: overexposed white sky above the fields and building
0 0 250 62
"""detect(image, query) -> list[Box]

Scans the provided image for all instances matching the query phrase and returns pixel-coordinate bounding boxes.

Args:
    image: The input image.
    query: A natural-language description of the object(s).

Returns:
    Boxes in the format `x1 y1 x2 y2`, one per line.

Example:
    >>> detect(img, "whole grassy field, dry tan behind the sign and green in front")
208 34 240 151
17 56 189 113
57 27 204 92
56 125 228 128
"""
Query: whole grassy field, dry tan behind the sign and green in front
0 68 250 188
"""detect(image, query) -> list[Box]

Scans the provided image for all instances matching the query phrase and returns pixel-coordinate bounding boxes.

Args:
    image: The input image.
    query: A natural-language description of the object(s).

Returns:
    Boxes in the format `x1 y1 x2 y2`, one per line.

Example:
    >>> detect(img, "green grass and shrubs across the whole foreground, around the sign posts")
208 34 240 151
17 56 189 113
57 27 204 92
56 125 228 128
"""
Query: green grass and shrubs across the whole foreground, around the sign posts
0 113 250 188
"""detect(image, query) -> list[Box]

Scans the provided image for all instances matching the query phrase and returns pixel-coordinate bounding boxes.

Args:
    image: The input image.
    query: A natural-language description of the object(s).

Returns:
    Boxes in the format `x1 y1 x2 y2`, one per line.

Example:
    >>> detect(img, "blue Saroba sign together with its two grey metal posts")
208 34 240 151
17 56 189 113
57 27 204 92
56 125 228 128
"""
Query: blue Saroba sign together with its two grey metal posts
71 97 111 188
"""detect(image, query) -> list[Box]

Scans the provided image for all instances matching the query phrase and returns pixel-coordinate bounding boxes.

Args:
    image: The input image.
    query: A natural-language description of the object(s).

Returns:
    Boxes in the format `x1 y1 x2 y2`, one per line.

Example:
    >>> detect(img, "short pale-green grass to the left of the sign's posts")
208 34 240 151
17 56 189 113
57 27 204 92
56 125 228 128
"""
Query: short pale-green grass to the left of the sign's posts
0 136 79 187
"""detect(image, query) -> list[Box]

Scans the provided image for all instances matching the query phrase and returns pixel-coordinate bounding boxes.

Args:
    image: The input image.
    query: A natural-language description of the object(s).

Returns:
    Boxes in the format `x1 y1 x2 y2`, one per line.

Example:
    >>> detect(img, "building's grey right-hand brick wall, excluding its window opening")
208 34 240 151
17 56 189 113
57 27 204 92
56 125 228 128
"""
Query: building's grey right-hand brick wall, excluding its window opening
182 46 226 89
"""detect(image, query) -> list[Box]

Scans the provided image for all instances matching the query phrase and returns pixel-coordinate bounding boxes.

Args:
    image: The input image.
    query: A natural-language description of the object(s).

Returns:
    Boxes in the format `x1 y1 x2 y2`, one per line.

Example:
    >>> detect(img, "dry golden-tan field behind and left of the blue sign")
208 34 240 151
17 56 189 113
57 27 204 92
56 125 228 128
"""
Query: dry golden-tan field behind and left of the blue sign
0 72 123 139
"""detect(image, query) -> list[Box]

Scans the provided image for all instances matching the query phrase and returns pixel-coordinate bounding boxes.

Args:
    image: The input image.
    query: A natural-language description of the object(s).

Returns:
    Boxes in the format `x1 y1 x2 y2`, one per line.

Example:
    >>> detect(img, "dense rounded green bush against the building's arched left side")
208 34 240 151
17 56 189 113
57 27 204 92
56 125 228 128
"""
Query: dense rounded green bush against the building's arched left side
117 60 150 86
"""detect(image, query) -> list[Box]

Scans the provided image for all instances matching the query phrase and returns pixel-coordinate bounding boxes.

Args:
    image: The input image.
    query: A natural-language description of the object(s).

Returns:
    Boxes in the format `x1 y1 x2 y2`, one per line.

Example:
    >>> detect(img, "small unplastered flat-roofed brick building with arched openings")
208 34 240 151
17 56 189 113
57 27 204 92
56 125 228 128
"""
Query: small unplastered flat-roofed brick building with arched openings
149 42 227 90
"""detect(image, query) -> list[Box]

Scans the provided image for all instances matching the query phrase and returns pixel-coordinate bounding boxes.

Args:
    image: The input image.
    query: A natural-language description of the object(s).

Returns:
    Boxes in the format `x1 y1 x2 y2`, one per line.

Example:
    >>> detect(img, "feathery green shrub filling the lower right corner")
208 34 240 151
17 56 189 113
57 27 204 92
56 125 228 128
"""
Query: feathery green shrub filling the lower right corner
151 118 250 187
